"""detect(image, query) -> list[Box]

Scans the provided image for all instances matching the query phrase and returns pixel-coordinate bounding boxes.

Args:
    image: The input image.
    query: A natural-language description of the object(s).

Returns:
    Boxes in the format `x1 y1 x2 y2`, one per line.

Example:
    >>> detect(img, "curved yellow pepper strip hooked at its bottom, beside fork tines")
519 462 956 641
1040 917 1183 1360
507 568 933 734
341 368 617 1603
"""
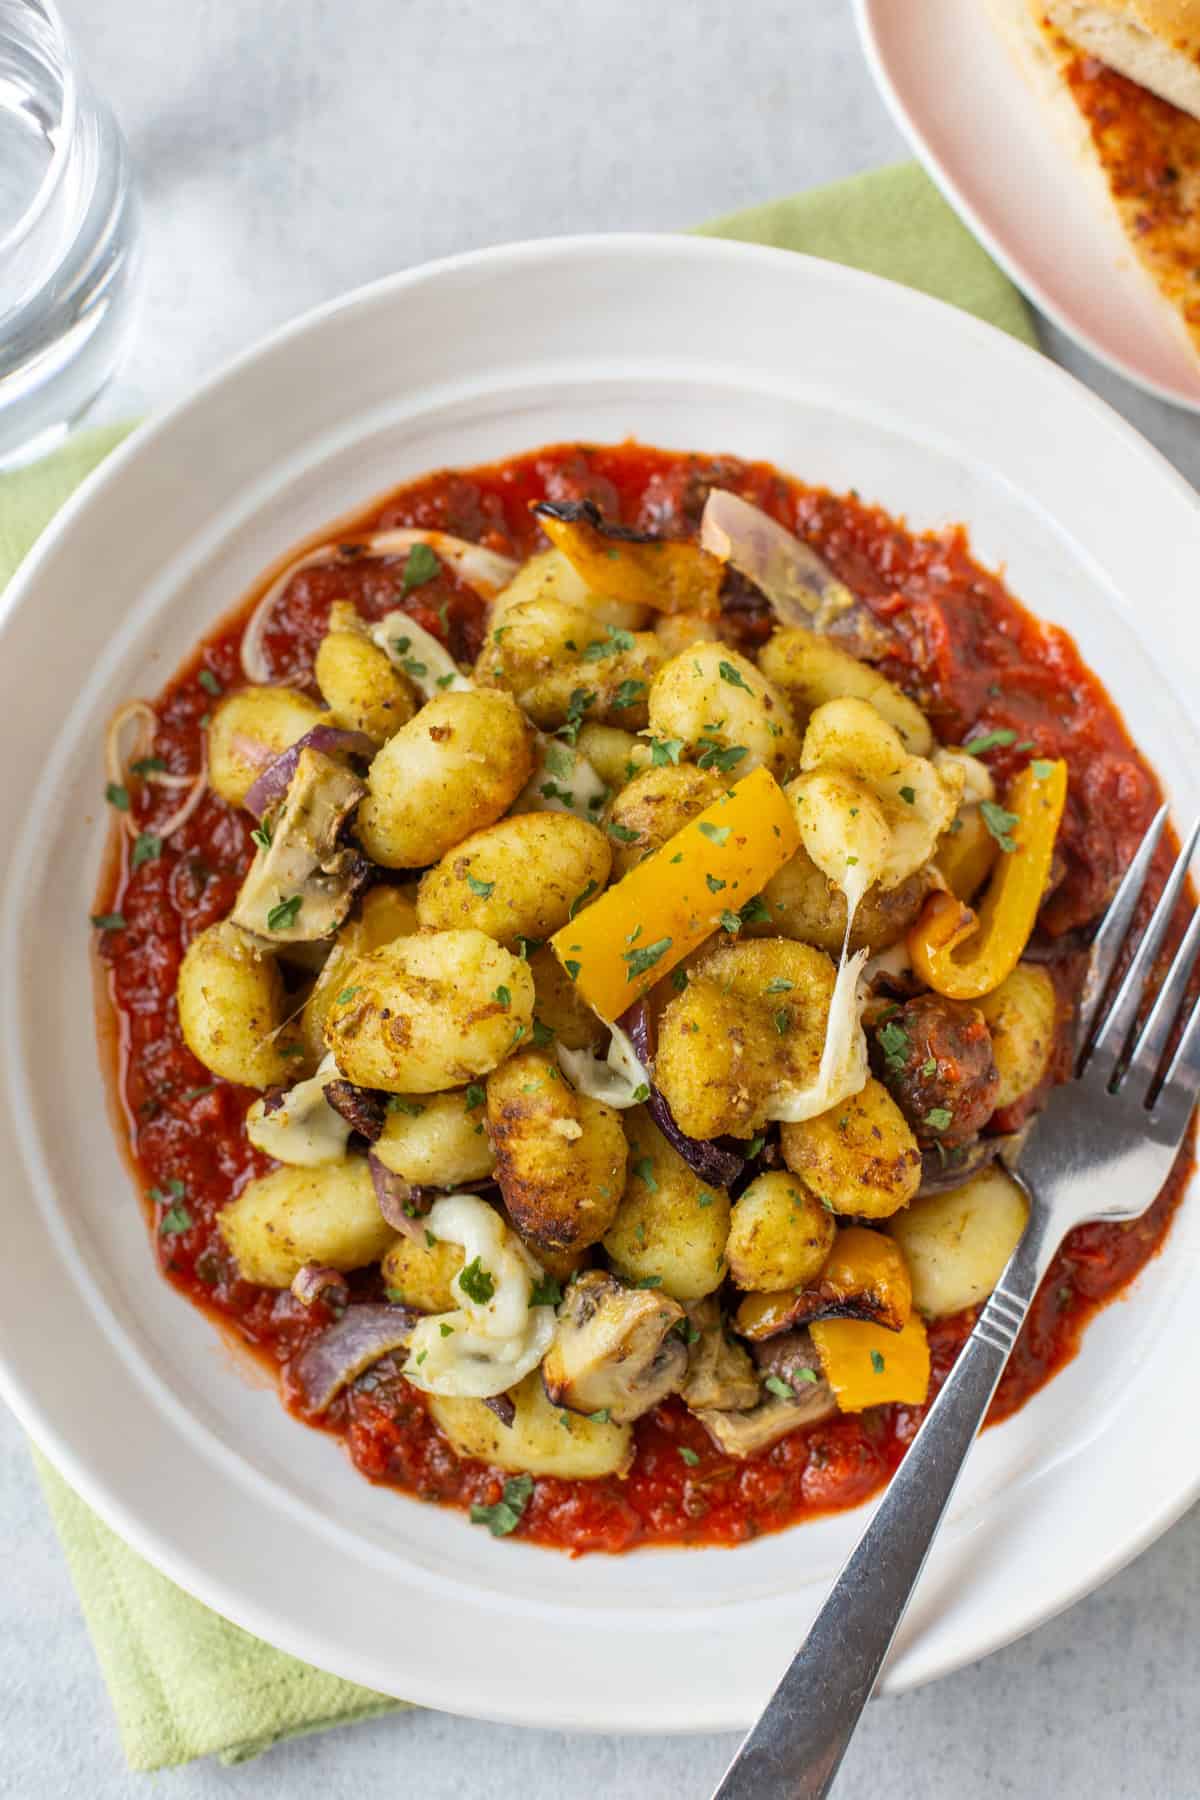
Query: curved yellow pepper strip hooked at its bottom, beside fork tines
909 761 1067 1001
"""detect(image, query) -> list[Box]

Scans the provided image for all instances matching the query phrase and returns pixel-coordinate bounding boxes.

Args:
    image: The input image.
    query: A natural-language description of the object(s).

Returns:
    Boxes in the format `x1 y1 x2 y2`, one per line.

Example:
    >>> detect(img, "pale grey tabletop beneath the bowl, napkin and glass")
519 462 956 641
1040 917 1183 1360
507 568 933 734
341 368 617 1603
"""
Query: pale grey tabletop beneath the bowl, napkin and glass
0 0 1200 1800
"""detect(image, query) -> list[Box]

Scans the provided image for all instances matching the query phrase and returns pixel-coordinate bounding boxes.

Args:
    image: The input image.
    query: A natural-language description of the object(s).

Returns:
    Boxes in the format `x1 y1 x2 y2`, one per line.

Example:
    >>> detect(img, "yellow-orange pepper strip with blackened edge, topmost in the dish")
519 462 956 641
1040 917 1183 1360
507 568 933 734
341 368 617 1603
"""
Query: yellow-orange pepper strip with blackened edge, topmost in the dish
531 500 725 614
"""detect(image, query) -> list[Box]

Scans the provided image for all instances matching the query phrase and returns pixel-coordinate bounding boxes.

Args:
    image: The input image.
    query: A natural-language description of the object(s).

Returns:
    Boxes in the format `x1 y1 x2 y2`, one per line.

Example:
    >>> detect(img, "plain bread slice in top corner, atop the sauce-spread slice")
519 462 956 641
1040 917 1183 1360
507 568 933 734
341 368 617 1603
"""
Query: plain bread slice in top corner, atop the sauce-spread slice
1045 0 1200 119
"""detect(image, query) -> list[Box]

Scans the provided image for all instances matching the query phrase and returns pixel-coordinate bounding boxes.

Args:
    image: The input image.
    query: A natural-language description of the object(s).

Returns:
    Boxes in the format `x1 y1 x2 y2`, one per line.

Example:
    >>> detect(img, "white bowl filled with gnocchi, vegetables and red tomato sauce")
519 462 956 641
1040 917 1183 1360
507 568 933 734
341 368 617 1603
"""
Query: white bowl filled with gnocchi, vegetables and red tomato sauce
0 239 1196 1728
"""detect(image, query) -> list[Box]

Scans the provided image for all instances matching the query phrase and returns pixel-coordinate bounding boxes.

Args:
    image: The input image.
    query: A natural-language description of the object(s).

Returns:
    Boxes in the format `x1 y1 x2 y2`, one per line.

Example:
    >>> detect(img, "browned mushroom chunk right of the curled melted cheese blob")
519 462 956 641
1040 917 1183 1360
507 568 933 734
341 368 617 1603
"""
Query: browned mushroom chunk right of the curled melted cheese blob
542 1269 687 1426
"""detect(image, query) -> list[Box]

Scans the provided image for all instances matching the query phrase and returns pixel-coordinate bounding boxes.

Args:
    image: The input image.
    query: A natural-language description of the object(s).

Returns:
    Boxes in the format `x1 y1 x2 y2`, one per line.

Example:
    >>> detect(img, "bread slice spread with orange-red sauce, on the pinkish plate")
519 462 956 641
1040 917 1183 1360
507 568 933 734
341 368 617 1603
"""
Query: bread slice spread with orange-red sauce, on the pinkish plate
986 0 1200 355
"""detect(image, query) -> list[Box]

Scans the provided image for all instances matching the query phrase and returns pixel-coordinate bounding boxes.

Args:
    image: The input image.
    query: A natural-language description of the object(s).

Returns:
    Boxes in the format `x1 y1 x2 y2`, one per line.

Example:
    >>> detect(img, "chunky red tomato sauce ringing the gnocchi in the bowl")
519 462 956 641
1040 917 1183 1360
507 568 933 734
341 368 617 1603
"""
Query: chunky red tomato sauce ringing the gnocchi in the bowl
97 443 1191 1553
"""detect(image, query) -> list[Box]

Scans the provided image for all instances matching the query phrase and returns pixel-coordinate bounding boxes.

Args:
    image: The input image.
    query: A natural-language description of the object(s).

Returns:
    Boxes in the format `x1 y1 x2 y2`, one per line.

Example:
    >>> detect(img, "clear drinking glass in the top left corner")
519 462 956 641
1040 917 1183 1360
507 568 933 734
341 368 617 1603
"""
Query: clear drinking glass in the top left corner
0 0 140 466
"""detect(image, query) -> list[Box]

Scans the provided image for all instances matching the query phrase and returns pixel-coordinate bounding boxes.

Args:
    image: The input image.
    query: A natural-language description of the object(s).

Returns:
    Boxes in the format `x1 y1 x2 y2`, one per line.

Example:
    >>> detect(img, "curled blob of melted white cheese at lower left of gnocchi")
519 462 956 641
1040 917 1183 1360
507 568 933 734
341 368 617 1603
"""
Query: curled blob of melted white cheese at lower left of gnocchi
405 1193 554 1400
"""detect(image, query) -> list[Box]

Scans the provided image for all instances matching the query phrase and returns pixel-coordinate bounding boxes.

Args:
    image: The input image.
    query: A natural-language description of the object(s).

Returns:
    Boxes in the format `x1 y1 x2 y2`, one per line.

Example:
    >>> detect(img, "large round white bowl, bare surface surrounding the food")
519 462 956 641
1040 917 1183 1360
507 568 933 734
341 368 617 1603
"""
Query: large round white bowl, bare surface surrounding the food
0 238 1200 1730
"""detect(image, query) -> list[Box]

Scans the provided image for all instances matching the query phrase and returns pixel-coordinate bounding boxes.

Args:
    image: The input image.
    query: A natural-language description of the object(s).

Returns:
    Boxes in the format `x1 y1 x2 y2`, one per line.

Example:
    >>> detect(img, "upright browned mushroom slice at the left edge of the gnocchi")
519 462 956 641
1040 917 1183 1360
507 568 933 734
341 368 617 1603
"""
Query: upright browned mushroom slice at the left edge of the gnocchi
232 749 369 943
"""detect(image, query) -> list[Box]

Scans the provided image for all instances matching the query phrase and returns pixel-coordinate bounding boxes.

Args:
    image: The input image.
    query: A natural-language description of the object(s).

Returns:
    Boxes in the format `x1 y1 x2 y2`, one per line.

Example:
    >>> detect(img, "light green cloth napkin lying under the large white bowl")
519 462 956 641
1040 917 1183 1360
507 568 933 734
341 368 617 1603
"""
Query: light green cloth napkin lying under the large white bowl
0 164 1036 1769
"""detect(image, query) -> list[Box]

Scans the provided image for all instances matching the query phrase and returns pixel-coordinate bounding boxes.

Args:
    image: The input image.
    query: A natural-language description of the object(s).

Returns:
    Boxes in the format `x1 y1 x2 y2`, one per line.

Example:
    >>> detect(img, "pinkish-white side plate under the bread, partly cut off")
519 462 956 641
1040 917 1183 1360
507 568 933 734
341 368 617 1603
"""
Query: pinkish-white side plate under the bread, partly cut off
855 0 1200 412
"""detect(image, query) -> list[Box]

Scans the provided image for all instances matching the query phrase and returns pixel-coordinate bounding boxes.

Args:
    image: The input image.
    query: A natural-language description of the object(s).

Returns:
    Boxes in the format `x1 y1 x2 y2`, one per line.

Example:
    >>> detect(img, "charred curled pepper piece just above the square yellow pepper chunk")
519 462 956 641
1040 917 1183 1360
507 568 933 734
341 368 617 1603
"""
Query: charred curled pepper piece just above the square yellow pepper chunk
736 1226 912 1341
